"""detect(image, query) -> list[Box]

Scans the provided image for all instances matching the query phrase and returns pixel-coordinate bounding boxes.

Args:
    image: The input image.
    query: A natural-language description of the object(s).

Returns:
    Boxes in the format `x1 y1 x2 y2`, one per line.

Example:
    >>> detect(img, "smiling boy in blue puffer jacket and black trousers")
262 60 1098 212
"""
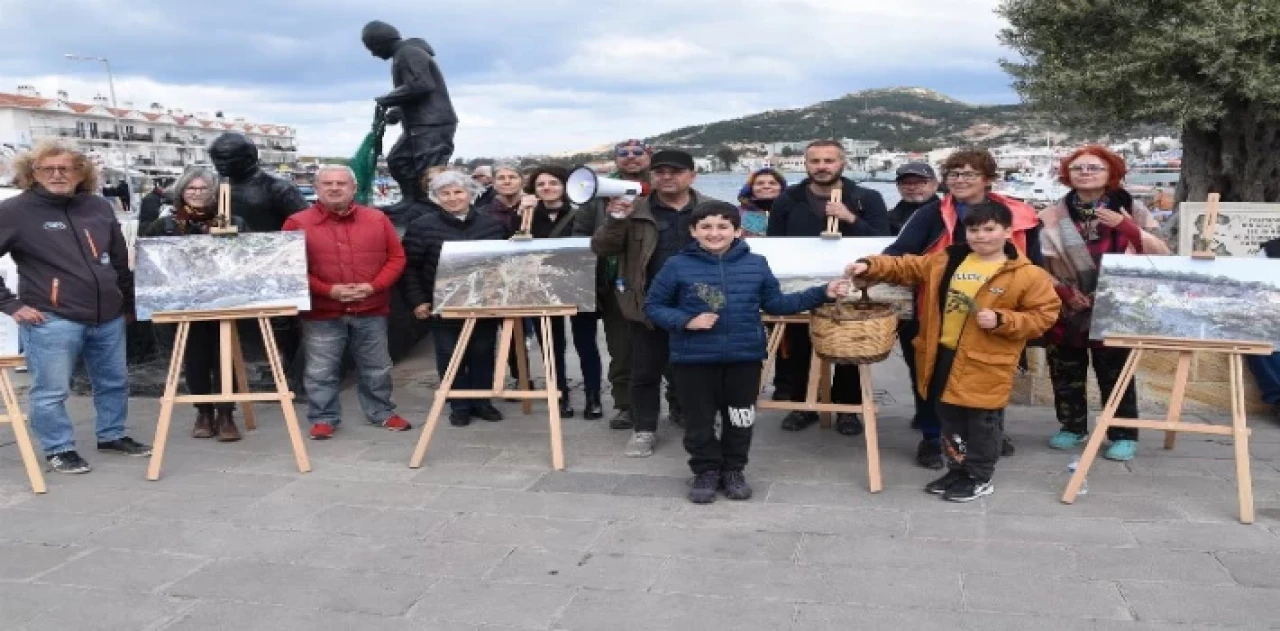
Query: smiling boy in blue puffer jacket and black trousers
644 201 849 504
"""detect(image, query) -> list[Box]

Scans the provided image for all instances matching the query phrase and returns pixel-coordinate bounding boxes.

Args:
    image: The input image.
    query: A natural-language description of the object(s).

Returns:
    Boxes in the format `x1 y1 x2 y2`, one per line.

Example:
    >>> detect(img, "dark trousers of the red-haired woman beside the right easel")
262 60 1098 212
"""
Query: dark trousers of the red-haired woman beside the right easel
1046 344 1138 440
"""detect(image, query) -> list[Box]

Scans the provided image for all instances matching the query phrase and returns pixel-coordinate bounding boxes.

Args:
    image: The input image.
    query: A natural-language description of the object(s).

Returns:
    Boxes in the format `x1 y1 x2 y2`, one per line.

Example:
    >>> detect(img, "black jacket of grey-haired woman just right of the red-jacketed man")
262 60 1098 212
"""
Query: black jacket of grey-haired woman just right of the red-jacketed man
401 209 504 307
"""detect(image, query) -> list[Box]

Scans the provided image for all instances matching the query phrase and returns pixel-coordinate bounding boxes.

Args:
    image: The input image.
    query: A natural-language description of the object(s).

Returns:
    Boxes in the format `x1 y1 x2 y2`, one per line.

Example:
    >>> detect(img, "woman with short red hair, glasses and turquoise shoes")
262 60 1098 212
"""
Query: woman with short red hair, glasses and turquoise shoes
1039 145 1169 461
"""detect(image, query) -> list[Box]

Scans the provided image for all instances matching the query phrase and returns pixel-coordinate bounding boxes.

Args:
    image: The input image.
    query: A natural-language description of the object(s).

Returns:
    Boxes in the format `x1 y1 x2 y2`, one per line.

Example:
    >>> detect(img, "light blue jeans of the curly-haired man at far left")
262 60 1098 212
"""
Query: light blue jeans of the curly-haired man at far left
20 312 129 456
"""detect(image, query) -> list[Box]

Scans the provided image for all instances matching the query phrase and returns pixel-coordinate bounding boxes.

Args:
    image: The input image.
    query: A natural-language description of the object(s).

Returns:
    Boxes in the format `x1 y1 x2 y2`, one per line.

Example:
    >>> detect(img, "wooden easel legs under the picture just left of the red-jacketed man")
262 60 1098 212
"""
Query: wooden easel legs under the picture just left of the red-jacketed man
147 307 311 480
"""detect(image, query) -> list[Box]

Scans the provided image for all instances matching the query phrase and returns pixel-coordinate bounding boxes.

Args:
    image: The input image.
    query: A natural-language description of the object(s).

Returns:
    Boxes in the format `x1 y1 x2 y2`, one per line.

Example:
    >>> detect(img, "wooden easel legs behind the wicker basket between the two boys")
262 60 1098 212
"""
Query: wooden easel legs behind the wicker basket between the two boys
755 315 884 493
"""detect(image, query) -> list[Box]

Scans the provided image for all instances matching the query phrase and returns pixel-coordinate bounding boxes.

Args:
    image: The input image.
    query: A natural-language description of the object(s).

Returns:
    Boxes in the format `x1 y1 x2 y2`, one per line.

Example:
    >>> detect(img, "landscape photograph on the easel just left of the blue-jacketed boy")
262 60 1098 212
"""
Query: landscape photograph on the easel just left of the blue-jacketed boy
431 237 595 314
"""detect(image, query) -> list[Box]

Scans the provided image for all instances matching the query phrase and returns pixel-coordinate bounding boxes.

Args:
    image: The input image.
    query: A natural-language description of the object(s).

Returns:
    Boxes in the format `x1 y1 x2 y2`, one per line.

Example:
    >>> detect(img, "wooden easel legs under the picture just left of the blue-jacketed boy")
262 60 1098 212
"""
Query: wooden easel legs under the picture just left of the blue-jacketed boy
408 302 577 471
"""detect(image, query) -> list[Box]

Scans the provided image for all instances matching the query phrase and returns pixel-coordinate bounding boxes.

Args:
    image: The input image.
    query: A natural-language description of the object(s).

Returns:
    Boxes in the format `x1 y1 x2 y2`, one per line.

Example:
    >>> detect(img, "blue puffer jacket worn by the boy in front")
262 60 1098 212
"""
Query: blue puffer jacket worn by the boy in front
644 239 827 363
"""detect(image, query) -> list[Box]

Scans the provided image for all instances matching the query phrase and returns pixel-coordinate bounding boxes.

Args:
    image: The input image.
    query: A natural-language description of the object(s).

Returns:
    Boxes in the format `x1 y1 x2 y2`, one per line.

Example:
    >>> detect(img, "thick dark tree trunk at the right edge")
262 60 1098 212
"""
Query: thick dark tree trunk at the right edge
1178 101 1280 202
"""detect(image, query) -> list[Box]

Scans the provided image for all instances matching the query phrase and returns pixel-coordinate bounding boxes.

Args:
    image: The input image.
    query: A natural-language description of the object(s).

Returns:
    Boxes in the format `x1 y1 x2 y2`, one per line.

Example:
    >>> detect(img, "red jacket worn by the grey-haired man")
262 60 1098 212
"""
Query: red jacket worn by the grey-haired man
284 202 404 320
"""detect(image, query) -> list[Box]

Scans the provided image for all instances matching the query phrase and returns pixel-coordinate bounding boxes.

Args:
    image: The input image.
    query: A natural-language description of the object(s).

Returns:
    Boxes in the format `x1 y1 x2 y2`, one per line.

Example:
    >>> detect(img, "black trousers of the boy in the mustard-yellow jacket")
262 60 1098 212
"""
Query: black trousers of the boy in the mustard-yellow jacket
929 346 1005 483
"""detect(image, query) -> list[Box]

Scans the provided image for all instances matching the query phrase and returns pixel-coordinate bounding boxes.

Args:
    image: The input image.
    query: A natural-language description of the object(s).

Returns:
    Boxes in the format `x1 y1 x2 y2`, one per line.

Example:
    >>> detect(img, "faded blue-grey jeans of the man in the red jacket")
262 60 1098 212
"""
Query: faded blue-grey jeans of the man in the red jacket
302 316 396 425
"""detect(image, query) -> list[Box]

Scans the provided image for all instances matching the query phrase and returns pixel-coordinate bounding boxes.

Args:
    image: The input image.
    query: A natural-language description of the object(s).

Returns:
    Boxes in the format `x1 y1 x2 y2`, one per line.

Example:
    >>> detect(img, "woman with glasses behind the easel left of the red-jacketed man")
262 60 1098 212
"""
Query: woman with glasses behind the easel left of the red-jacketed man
141 168 247 443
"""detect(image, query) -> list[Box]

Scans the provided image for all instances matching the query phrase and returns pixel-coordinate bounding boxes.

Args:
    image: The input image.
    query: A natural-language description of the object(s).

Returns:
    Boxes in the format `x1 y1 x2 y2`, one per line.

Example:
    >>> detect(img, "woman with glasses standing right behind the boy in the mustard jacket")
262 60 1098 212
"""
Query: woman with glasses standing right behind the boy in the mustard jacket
884 148 1044 468
